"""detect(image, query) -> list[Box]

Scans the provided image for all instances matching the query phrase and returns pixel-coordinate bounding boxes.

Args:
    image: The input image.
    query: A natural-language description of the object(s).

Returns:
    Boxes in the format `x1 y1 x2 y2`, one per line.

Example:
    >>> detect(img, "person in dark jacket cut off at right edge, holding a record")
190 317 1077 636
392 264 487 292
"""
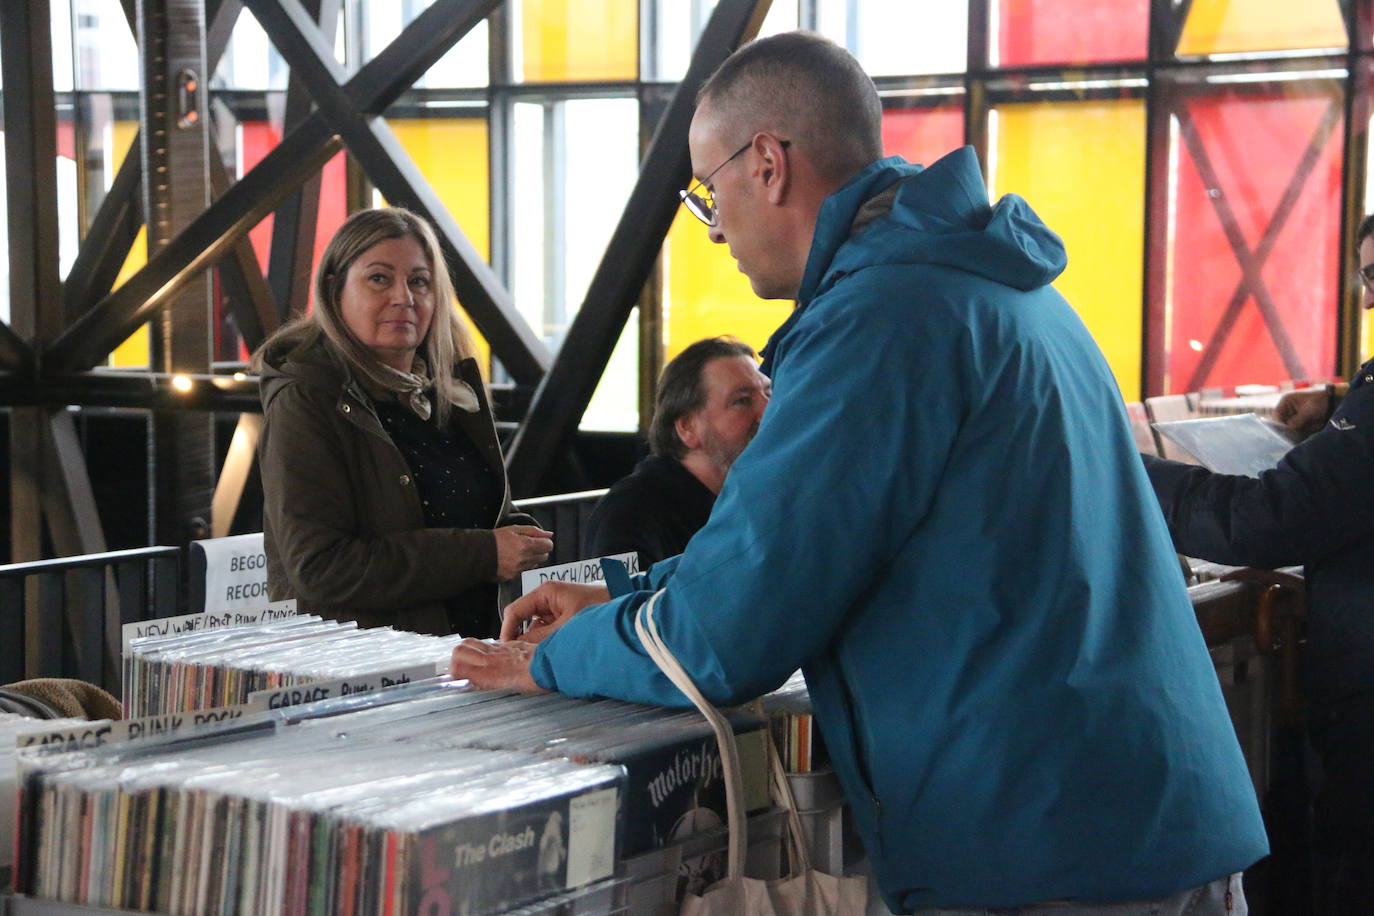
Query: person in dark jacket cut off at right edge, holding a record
1145 217 1374 916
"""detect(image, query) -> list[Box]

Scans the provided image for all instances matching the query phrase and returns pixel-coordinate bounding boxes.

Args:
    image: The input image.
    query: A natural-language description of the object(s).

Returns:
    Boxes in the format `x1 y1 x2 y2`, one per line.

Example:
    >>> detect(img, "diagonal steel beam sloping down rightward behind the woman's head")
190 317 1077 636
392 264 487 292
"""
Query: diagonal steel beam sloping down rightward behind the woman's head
246 0 550 385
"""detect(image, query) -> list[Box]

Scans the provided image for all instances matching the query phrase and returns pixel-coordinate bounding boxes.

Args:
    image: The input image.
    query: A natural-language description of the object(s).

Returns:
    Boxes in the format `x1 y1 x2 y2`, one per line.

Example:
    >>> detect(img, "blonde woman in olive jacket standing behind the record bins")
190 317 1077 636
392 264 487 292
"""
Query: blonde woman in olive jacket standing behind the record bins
254 209 552 636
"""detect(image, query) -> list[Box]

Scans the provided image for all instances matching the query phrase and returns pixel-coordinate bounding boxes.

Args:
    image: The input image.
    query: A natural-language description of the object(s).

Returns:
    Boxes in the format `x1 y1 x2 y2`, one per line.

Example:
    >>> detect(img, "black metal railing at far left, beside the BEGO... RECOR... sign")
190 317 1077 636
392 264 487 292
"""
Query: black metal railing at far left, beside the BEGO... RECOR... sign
0 547 181 695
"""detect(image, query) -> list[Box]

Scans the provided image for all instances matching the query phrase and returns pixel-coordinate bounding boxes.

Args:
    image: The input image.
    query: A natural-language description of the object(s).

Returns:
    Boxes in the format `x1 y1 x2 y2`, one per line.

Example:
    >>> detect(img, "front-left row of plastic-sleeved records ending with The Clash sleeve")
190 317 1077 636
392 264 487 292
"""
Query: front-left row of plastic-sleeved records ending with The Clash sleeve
16 694 622 915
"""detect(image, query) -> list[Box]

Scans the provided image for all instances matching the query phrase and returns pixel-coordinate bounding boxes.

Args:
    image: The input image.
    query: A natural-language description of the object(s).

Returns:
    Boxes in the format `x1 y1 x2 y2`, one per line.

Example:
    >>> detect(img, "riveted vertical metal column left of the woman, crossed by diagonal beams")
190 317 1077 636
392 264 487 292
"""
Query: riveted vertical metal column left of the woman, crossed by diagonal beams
137 0 214 544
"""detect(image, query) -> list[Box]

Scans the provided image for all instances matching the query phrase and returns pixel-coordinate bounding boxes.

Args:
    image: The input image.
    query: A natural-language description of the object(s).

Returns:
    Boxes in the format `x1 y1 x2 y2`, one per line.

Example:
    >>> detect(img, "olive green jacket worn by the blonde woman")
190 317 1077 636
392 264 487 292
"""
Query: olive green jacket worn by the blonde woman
258 345 533 636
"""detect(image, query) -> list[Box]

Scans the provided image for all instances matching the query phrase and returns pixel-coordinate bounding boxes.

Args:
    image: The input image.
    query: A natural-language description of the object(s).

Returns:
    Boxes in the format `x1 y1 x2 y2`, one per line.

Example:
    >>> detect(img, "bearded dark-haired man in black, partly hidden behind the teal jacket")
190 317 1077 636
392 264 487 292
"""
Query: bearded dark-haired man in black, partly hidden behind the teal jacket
587 336 772 569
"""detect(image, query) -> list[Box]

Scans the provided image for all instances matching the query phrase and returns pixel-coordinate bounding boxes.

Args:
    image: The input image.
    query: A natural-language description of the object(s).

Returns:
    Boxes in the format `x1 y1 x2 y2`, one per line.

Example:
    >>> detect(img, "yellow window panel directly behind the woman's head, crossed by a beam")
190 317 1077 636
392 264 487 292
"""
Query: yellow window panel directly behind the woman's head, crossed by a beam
389 118 492 372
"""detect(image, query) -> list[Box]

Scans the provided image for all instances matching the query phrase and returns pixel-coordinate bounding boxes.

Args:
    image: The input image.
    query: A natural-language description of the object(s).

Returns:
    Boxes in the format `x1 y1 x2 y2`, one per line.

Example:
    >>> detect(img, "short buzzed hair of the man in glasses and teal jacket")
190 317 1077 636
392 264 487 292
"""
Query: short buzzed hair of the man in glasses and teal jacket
697 32 882 184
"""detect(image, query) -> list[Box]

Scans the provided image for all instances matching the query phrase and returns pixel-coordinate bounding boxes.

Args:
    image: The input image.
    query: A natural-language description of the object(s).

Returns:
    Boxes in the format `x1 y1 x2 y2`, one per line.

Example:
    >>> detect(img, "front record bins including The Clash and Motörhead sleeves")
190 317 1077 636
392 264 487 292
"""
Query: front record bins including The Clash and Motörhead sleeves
15 683 785 915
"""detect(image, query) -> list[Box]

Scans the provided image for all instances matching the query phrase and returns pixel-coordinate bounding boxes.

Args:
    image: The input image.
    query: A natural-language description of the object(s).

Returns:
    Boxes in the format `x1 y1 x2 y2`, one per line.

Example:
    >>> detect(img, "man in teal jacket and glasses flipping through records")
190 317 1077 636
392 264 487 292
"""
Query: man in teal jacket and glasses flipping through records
453 33 1267 915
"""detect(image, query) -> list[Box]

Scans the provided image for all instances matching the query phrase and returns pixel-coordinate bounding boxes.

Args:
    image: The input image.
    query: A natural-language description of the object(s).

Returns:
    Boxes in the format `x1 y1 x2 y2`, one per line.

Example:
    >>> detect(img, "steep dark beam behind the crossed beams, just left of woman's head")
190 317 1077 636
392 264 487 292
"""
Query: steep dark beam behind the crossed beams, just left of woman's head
268 0 342 320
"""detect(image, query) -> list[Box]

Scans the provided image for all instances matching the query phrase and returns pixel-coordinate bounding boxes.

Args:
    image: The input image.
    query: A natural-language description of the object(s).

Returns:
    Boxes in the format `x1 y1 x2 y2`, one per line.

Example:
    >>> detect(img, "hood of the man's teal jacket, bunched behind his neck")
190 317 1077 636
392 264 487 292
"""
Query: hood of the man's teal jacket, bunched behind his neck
797 147 1068 306
